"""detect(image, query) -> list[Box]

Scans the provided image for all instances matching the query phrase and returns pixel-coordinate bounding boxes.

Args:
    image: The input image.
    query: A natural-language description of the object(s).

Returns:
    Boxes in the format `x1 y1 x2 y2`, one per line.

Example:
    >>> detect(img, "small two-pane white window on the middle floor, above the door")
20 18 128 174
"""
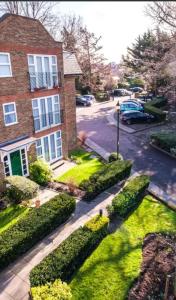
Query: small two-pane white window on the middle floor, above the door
3 102 17 126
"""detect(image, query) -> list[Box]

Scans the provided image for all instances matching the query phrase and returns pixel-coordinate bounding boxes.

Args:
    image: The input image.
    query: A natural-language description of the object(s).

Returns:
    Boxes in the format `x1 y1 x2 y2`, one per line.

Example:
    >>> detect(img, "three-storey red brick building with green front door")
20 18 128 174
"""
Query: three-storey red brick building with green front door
0 14 81 188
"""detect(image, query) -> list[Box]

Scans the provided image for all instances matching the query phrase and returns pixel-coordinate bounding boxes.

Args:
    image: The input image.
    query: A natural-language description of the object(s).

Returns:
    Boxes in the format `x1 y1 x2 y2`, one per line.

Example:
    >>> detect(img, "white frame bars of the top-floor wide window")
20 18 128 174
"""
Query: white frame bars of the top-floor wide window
27 54 59 91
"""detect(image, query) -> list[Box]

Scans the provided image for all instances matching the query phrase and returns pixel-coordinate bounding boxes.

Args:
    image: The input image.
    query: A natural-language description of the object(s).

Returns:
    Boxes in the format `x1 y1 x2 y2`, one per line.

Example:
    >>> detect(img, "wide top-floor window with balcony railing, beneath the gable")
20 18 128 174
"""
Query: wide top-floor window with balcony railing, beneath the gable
28 54 58 91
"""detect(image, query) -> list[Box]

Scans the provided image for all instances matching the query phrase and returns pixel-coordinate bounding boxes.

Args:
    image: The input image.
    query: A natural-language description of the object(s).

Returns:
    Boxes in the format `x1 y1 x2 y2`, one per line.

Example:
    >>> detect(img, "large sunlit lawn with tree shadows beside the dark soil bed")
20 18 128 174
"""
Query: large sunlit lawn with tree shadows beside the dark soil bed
70 196 176 300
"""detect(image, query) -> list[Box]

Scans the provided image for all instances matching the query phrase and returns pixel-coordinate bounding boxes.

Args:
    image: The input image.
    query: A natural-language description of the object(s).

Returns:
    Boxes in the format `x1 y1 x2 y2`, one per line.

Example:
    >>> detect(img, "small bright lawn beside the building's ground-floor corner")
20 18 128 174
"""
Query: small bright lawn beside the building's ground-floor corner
56 148 103 185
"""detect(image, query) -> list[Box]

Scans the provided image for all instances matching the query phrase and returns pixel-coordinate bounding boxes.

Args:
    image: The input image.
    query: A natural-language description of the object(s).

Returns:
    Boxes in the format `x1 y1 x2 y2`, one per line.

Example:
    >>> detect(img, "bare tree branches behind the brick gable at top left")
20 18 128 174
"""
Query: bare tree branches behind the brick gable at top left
0 1 60 36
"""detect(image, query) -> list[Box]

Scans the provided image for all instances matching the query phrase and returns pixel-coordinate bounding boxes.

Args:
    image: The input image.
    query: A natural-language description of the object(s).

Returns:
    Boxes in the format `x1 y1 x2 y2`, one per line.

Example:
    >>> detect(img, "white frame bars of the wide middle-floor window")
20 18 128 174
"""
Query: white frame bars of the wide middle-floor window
32 94 62 132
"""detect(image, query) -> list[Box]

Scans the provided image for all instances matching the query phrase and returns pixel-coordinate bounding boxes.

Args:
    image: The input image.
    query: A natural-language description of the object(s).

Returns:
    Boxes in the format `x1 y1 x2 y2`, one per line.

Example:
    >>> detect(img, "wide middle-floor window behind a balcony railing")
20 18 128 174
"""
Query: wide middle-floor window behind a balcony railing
32 95 61 132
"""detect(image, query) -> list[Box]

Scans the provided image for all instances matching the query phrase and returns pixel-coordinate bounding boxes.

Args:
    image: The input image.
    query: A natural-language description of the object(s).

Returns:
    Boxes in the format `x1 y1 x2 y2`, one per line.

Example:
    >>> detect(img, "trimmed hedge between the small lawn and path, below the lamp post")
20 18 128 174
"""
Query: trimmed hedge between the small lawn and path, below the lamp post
80 160 132 201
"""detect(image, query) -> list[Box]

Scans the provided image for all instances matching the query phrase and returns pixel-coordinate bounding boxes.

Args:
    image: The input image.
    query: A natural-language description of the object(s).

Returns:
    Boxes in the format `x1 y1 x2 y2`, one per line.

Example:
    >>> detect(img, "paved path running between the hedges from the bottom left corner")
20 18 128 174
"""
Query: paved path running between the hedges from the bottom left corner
0 185 120 300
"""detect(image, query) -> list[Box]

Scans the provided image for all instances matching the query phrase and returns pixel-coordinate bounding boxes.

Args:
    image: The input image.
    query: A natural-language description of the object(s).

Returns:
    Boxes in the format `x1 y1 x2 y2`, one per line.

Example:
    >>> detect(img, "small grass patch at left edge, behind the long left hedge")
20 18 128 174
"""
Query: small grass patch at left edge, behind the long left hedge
0 204 29 233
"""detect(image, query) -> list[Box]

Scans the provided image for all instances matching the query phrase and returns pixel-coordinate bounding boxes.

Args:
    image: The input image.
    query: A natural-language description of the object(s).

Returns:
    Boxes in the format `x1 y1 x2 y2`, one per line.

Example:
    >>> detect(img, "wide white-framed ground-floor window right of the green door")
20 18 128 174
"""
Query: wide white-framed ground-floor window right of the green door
36 130 62 162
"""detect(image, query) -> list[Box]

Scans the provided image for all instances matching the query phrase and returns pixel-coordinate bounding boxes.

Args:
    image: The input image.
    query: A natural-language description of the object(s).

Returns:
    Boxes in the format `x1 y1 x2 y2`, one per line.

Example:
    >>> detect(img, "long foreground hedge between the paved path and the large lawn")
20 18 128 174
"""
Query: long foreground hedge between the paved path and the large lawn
30 215 109 287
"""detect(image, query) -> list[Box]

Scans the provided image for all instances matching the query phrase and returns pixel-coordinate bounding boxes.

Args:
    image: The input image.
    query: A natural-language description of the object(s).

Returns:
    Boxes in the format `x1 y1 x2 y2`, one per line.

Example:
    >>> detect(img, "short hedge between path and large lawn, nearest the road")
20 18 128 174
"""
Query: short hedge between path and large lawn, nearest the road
107 175 150 218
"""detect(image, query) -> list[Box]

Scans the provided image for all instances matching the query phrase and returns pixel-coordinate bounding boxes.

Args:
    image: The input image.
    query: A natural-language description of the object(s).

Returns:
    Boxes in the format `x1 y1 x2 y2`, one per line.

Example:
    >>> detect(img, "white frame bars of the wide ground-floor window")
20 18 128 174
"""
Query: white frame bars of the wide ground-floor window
36 130 63 164
